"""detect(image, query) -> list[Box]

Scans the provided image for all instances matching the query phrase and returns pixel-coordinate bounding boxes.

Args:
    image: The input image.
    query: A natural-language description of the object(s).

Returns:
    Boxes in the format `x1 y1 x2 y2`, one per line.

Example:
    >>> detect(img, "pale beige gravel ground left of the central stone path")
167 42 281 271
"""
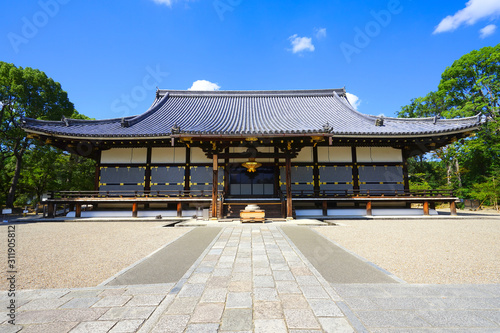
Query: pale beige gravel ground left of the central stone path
0 222 192 290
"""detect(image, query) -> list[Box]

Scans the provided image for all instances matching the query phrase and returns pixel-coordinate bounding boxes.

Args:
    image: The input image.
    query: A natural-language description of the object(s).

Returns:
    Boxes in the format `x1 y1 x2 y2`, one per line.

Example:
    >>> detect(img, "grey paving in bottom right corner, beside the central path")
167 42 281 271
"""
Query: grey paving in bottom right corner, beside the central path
332 284 500 333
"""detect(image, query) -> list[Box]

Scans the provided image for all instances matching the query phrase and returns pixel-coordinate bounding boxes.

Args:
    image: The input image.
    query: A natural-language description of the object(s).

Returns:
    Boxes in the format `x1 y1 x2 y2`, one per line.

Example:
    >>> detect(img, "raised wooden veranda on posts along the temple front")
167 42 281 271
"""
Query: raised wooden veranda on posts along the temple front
42 190 458 218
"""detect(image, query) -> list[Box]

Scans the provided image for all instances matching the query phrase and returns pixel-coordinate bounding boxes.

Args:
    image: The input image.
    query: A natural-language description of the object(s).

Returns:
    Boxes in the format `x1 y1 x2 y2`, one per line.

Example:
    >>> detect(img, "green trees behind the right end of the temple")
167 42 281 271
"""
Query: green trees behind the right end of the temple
398 44 500 205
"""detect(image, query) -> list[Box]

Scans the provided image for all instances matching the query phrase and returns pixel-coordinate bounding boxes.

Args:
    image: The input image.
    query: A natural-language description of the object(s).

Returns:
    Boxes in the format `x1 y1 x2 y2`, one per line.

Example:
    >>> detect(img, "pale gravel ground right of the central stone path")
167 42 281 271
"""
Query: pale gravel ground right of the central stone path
315 217 500 284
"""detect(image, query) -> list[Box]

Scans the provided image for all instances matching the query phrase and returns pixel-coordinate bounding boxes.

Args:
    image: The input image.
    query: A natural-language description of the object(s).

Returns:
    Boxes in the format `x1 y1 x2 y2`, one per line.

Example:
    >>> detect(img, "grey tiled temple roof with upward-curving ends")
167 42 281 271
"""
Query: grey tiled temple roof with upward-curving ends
23 89 483 138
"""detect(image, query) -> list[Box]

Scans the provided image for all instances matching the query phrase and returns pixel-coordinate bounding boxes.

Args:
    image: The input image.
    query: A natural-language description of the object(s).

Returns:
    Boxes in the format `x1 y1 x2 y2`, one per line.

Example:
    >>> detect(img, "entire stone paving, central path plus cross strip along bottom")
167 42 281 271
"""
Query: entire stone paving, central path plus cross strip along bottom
0 225 500 333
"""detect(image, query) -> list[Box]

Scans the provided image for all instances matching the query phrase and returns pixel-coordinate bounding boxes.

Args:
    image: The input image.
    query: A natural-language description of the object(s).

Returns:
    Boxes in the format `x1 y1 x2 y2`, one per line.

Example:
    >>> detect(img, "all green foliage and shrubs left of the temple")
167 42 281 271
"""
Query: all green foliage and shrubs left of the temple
0 62 93 207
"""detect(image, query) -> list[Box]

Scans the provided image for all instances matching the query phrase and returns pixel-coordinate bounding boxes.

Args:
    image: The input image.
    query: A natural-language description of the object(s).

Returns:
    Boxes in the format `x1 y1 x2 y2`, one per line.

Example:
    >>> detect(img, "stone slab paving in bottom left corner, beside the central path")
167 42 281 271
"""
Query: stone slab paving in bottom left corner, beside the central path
0 283 174 333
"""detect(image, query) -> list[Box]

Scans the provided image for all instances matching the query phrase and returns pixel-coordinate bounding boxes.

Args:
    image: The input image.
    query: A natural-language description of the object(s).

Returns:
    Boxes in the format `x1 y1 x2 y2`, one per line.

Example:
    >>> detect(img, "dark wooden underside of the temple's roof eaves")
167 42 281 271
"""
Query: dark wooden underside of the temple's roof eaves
24 129 475 160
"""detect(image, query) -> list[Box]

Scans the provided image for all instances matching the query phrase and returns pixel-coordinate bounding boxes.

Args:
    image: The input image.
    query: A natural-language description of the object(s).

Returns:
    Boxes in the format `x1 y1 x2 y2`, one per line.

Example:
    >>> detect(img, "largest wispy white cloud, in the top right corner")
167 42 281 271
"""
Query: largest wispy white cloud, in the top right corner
434 0 500 34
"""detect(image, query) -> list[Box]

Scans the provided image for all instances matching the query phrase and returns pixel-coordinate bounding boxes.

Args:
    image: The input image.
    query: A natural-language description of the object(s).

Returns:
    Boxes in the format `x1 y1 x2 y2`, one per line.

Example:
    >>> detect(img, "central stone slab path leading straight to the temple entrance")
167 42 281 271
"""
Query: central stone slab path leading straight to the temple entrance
148 226 354 332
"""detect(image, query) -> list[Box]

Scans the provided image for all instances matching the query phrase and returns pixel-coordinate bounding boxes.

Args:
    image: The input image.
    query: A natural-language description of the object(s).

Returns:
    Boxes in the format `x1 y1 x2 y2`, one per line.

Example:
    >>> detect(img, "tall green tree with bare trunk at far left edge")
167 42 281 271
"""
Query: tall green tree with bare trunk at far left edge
0 62 74 207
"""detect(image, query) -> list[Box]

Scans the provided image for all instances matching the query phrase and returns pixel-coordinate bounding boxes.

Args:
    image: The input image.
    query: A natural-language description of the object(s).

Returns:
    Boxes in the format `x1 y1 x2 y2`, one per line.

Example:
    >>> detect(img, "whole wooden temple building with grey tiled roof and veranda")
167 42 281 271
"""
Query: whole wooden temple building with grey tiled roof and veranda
23 89 485 218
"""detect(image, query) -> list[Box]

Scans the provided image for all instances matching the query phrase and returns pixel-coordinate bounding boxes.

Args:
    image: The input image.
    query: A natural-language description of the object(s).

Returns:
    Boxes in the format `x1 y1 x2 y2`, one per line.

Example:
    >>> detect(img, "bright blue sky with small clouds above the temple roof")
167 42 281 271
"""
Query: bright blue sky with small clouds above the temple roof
0 0 500 119
